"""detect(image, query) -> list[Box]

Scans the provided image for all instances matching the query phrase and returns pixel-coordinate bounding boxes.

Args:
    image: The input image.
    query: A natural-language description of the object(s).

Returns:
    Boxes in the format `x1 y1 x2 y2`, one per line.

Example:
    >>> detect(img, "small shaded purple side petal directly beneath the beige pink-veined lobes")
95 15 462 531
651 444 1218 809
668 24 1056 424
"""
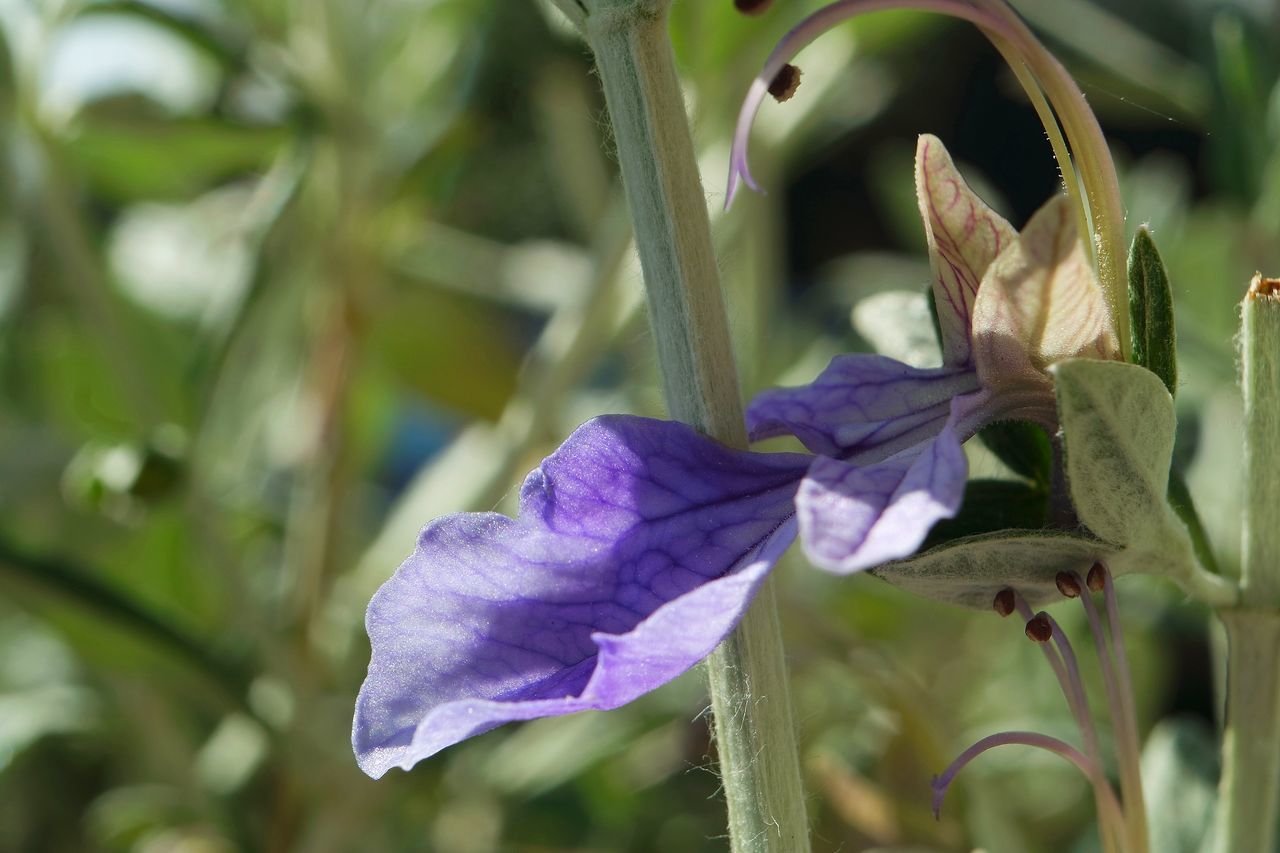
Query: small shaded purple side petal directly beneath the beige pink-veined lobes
746 353 978 464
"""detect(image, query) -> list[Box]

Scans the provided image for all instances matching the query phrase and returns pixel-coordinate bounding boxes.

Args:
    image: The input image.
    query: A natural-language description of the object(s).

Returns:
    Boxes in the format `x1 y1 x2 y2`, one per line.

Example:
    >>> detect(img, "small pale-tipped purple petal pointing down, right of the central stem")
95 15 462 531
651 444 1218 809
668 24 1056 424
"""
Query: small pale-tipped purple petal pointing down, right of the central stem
796 400 969 574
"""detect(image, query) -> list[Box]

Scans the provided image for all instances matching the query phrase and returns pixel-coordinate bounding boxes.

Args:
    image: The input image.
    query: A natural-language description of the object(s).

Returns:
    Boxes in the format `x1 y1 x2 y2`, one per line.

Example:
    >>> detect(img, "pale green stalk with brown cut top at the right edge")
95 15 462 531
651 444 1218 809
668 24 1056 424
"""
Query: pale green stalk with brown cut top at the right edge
1215 275 1280 853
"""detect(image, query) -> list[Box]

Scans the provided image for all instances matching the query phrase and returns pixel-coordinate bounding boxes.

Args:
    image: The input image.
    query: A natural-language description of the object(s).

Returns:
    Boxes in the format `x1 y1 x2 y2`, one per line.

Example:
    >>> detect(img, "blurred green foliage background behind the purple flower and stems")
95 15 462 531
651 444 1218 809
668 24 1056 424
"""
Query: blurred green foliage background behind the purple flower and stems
0 0 1280 853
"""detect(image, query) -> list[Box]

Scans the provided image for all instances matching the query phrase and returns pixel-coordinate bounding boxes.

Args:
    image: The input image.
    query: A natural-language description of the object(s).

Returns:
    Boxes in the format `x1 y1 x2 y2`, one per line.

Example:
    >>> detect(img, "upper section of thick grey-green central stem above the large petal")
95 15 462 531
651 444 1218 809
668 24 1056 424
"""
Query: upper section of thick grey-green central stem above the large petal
586 0 746 446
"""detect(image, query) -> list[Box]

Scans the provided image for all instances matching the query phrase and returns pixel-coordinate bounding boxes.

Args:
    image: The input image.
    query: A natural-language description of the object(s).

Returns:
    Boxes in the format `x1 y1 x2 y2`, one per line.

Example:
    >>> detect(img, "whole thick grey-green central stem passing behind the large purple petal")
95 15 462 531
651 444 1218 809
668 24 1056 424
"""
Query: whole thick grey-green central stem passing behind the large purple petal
581 0 809 853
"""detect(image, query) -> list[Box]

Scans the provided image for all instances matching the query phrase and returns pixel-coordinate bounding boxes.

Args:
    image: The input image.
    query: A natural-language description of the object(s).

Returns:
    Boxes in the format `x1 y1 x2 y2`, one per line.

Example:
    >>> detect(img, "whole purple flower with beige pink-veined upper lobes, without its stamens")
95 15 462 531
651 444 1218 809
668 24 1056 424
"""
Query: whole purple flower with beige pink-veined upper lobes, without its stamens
352 137 1116 777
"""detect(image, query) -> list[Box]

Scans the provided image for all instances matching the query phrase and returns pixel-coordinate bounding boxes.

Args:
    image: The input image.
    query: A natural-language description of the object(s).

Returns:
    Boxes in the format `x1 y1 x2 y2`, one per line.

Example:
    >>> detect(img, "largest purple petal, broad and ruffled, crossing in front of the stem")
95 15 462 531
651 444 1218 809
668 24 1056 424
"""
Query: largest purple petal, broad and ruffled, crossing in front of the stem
352 416 812 777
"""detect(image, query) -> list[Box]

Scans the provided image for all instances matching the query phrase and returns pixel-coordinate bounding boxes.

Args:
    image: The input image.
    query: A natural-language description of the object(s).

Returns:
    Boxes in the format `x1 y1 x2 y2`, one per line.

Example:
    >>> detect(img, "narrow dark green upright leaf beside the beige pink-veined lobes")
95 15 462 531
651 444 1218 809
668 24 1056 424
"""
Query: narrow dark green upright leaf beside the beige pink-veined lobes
1129 228 1178 394
